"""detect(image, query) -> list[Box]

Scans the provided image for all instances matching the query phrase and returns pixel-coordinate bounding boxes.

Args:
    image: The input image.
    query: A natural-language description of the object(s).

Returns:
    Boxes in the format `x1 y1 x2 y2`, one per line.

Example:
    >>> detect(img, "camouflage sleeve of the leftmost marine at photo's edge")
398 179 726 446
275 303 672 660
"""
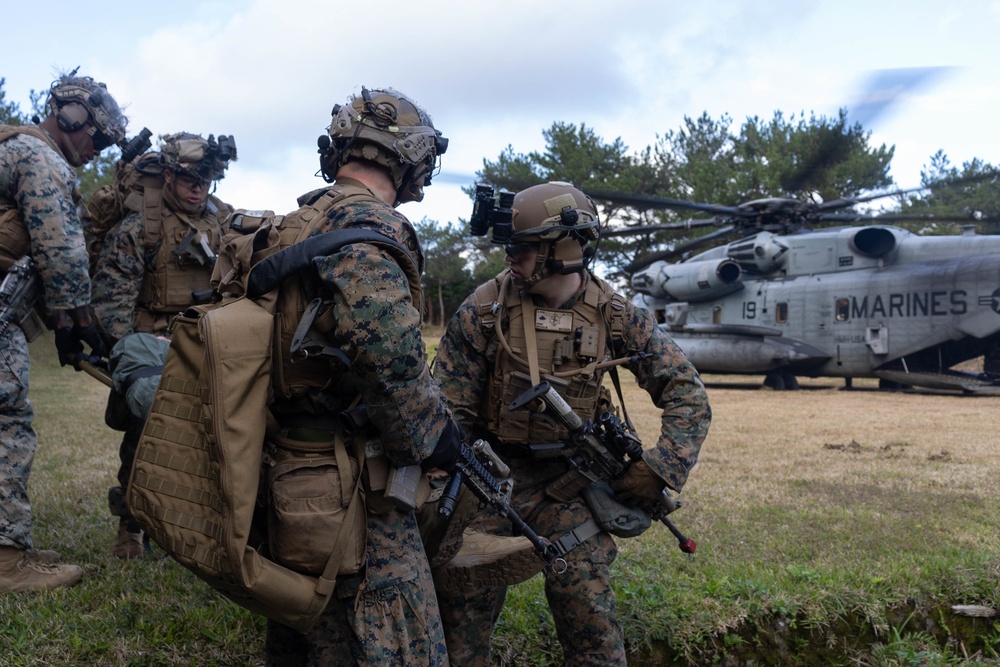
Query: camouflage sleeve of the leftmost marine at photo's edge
9 137 90 309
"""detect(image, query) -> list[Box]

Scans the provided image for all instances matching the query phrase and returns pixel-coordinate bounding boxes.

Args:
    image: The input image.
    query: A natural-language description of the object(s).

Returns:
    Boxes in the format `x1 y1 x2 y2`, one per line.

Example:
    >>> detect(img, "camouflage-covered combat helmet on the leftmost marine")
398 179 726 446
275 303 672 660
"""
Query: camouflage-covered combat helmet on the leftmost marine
46 70 128 152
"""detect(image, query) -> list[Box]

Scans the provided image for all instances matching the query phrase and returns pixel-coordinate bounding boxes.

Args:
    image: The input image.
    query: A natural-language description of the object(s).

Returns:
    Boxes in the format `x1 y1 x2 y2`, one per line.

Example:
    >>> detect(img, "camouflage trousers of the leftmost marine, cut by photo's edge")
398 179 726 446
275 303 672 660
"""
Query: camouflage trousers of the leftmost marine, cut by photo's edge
0 326 38 549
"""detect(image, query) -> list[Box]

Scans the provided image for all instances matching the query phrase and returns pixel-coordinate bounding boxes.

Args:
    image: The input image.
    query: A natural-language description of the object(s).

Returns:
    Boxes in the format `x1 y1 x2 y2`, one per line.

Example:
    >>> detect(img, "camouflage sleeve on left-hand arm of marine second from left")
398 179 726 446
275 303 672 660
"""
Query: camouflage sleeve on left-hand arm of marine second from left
91 212 145 340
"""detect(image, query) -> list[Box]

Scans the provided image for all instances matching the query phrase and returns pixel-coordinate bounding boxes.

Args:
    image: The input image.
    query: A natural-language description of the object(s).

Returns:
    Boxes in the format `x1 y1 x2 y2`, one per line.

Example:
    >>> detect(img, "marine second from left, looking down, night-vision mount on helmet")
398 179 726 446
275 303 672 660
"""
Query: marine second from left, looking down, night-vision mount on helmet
88 132 236 559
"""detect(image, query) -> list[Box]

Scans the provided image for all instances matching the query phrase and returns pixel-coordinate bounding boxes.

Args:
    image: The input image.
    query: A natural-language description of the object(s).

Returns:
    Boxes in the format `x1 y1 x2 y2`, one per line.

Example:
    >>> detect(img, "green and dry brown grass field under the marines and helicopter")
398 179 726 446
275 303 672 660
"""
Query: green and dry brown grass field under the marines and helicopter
0 338 1000 665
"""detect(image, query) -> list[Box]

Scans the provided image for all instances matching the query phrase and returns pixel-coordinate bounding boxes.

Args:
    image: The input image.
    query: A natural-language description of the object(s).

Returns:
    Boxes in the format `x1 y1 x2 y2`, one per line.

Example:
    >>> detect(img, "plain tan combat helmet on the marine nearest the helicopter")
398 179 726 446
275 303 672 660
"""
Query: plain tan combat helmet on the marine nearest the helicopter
507 181 600 282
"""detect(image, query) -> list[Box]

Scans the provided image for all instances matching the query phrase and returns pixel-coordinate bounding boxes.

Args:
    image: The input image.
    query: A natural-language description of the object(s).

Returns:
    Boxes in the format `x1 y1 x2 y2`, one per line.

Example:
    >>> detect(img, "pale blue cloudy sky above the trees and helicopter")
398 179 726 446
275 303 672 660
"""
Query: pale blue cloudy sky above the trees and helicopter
0 0 1000 228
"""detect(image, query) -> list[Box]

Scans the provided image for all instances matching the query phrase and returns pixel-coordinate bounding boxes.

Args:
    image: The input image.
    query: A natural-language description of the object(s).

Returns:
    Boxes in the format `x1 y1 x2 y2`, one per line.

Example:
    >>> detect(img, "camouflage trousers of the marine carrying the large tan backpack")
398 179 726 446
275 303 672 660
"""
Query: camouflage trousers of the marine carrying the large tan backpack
265 510 448 667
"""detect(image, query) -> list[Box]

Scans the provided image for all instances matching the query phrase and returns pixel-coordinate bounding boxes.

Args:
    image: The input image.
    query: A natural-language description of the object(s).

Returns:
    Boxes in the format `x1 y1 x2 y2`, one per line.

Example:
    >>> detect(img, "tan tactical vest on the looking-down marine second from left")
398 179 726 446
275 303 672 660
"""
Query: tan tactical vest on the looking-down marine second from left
125 166 232 333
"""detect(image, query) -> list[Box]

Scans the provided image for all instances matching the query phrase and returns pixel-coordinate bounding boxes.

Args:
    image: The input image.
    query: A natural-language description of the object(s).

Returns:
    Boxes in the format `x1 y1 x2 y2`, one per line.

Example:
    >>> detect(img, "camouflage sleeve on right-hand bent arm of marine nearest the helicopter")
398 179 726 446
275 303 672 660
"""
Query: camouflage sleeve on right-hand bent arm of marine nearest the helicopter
623 304 712 491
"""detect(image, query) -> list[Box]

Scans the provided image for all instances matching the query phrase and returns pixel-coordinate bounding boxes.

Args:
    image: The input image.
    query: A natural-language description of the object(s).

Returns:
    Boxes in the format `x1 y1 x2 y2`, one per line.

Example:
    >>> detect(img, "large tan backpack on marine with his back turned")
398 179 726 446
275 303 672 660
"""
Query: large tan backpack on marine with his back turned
127 226 414 632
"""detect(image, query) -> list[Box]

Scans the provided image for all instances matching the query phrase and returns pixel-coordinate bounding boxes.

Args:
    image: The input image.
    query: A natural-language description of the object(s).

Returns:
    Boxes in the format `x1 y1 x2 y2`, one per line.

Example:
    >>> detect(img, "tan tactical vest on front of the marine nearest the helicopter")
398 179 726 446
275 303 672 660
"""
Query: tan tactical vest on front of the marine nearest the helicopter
475 271 625 445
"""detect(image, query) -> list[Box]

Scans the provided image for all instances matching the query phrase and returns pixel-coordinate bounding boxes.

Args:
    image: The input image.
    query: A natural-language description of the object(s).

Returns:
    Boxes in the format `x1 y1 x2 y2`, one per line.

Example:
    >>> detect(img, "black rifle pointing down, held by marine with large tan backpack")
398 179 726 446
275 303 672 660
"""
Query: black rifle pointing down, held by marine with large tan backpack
438 440 565 565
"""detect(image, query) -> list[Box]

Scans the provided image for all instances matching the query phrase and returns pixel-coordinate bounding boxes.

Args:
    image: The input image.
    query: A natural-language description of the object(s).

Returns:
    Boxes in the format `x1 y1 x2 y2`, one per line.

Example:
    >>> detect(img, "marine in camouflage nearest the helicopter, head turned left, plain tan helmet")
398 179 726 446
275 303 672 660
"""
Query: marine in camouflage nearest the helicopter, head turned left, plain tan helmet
434 182 711 666
